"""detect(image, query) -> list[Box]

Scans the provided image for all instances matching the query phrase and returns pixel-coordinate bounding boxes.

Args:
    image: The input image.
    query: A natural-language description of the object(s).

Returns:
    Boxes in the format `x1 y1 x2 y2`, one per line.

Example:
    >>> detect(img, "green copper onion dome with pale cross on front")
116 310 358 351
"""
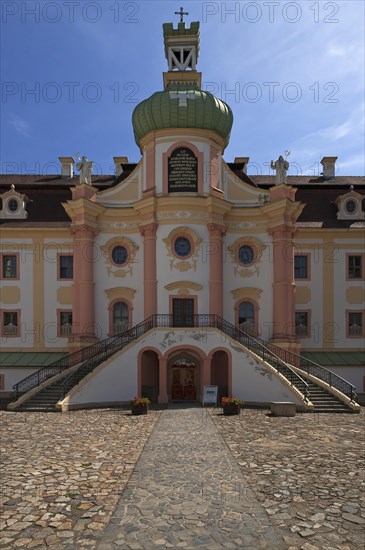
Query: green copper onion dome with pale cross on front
132 83 233 145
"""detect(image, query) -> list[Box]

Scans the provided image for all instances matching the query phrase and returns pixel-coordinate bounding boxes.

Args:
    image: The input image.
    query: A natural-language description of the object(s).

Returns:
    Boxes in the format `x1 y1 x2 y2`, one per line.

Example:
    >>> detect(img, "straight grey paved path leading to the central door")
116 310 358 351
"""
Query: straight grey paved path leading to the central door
97 408 288 550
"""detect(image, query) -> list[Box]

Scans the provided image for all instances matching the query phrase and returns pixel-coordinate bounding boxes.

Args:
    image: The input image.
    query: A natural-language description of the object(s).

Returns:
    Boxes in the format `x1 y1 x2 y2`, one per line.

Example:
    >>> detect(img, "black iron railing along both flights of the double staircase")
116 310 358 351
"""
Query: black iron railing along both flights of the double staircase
11 314 356 401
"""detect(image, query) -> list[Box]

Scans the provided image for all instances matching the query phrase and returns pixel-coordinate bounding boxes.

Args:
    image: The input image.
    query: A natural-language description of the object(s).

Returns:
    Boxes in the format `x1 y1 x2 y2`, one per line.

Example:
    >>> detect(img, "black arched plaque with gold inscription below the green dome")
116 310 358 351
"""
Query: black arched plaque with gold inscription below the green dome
168 147 198 193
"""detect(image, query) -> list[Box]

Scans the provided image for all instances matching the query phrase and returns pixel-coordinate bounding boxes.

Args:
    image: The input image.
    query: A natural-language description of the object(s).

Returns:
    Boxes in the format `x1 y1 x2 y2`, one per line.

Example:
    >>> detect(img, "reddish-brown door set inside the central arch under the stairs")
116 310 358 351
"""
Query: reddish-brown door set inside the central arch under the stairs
171 359 197 401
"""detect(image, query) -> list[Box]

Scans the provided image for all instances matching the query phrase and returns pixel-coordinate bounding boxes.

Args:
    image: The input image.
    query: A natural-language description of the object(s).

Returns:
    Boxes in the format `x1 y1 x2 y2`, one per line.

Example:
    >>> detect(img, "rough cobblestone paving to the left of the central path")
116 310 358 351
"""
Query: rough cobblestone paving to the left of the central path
0 409 160 550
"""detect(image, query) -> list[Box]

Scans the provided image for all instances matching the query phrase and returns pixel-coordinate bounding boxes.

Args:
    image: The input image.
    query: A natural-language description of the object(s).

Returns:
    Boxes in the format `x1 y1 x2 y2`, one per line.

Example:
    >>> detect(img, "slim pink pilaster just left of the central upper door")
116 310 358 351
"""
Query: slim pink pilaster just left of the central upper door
140 223 157 319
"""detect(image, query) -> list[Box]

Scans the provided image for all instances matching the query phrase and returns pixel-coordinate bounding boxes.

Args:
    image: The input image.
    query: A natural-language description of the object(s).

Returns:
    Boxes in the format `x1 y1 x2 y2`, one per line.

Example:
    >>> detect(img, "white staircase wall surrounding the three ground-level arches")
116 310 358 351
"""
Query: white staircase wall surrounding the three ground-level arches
65 329 299 404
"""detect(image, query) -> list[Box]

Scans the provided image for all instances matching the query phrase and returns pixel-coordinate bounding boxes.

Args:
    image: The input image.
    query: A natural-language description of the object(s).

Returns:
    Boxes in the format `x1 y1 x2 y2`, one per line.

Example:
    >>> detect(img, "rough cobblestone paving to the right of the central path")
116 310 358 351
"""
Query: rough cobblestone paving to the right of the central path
211 409 365 550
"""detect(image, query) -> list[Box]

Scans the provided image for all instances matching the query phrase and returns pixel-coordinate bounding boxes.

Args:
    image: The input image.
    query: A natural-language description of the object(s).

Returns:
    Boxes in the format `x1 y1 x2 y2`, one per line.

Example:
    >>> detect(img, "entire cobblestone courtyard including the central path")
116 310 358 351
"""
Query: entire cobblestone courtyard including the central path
0 408 365 550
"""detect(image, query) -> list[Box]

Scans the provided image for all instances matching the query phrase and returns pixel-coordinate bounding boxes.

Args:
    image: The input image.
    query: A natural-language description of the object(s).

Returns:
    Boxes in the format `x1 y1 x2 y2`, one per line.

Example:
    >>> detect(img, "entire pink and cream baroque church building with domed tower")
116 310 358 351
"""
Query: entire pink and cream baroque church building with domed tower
0 22 365 410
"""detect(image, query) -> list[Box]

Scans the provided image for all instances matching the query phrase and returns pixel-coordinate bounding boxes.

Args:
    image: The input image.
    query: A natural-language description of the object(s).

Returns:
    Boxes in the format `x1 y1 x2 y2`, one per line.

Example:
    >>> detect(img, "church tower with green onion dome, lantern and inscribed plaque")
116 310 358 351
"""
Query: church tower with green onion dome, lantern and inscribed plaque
132 18 233 195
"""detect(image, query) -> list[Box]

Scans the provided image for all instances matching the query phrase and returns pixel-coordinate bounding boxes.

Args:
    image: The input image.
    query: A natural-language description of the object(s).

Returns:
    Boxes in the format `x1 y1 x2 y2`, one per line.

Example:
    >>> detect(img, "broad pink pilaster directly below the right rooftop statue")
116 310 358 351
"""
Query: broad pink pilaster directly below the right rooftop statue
271 225 295 342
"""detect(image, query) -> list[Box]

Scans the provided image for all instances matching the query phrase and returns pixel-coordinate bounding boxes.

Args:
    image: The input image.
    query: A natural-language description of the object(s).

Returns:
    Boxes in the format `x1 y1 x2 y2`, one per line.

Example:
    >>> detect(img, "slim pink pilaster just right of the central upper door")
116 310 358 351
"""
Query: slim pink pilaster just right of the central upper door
208 223 225 317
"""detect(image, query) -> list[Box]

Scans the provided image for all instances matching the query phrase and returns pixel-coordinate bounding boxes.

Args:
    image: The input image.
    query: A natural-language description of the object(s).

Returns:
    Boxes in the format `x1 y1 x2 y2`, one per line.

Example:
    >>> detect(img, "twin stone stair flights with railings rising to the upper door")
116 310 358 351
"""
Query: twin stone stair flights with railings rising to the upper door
9 315 358 413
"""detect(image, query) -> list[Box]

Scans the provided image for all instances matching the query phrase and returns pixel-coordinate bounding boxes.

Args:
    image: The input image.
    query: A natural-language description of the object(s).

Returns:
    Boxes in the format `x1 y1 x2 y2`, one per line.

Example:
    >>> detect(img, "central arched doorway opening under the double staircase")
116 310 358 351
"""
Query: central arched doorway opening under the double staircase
168 351 200 401
